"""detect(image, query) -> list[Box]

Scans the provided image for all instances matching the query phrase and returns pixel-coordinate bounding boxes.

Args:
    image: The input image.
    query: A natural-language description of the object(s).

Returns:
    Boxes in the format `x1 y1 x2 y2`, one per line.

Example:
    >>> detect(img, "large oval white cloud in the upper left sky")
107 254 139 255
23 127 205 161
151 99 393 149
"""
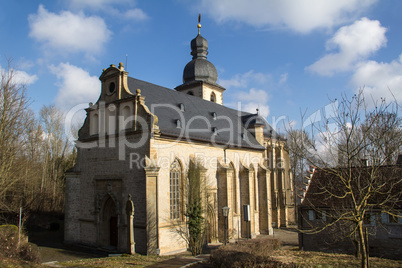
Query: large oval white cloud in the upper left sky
28 5 111 55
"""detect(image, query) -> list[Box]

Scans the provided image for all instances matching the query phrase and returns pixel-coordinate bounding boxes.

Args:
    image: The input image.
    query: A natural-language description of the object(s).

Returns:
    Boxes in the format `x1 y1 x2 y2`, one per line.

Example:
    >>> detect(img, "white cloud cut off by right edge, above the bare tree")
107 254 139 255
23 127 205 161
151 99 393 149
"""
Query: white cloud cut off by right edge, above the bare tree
351 54 402 105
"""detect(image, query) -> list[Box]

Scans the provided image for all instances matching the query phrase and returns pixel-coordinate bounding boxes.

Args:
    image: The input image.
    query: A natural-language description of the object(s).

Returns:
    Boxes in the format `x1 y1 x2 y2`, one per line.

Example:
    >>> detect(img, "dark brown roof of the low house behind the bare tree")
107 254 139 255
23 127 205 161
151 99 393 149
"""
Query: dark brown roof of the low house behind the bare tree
301 165 402 209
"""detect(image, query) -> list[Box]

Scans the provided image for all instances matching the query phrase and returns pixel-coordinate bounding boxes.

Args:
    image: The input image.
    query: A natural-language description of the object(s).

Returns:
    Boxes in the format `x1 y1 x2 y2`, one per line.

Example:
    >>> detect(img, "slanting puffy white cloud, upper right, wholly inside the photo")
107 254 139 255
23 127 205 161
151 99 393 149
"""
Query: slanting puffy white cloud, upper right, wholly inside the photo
306 18 387 76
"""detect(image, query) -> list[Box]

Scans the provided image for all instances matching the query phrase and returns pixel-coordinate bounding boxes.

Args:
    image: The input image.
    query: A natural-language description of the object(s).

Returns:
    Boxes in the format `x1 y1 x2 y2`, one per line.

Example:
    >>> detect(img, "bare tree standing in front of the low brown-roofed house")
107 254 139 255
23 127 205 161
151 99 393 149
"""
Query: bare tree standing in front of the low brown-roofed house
296 90 402 267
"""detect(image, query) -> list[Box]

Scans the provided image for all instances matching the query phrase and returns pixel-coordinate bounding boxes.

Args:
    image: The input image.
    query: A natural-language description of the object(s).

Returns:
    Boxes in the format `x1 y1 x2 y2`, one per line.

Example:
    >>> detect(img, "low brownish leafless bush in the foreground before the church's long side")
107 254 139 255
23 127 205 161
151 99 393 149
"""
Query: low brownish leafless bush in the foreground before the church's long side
210 238 297 267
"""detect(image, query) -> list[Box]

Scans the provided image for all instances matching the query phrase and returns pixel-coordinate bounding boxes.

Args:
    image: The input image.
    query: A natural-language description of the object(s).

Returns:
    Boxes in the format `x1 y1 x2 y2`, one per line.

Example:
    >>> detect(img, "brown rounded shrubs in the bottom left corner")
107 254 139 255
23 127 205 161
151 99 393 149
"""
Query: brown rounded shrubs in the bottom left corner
0 224 39 262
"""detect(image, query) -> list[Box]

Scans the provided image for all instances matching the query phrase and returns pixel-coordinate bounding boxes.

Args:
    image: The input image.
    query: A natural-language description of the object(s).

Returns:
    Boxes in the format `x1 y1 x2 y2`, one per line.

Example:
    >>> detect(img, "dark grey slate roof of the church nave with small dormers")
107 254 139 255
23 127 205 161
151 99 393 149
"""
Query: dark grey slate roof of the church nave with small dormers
128 77 279 150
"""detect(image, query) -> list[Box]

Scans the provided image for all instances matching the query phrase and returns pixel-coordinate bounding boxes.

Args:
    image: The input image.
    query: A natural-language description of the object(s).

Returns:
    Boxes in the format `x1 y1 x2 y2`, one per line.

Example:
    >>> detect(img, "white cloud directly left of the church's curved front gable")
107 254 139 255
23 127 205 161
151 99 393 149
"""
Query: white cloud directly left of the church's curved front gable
50 63 101 110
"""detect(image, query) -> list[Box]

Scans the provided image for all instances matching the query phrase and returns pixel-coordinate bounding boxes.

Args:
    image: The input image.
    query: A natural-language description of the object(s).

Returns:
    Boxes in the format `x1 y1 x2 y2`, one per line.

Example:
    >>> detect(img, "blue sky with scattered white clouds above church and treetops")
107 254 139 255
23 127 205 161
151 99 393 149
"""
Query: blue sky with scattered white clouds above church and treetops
0 0 402 130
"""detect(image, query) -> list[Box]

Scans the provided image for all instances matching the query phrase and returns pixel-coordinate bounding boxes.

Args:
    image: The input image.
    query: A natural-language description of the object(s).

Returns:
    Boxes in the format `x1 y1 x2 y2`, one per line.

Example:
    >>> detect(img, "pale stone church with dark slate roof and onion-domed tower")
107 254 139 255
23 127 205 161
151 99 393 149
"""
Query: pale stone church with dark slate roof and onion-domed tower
65 19 295 254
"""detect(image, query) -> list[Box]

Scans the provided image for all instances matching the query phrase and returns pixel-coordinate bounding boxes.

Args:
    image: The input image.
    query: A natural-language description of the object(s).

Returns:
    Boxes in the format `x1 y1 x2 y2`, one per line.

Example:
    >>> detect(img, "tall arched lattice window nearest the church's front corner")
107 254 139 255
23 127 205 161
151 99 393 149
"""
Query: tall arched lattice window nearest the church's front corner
169 159 181 220
